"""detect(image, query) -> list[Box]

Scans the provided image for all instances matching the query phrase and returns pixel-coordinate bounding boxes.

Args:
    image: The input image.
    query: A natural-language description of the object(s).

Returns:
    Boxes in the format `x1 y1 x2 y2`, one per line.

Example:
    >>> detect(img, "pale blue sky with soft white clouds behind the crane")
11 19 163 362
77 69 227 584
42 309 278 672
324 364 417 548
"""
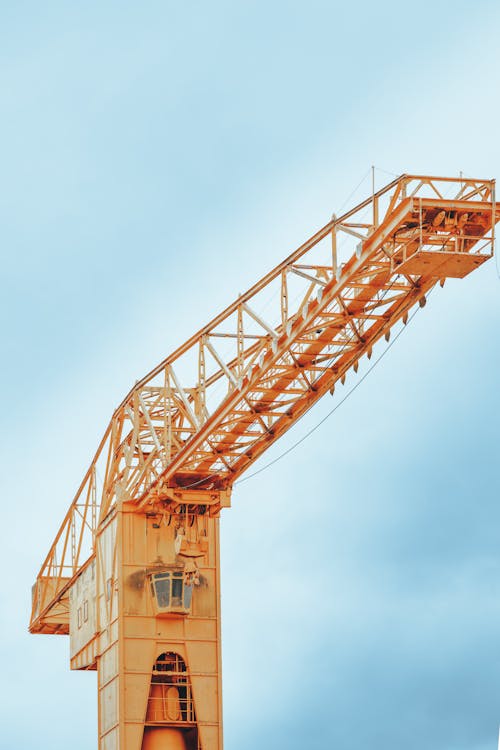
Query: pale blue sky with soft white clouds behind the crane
0 1 500 750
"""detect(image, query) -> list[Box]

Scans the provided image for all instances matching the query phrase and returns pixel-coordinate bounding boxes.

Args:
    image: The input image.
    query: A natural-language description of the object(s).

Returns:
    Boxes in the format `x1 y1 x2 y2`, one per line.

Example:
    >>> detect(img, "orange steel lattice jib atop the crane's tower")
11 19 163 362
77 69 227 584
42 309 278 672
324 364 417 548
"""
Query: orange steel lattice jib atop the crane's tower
32 175 500 632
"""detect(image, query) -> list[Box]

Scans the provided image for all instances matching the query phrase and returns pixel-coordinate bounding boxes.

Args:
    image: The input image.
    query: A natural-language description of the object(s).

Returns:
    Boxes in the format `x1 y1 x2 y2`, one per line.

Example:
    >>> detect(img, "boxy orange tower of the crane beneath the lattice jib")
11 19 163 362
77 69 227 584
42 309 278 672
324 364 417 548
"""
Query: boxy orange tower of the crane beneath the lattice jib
97 500 222 750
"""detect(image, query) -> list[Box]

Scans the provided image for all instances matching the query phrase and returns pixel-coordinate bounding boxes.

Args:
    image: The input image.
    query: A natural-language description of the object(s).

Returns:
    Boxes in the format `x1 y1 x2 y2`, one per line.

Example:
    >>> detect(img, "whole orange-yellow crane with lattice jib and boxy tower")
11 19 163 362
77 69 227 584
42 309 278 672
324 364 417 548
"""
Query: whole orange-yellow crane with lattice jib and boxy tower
30 175 500 750
